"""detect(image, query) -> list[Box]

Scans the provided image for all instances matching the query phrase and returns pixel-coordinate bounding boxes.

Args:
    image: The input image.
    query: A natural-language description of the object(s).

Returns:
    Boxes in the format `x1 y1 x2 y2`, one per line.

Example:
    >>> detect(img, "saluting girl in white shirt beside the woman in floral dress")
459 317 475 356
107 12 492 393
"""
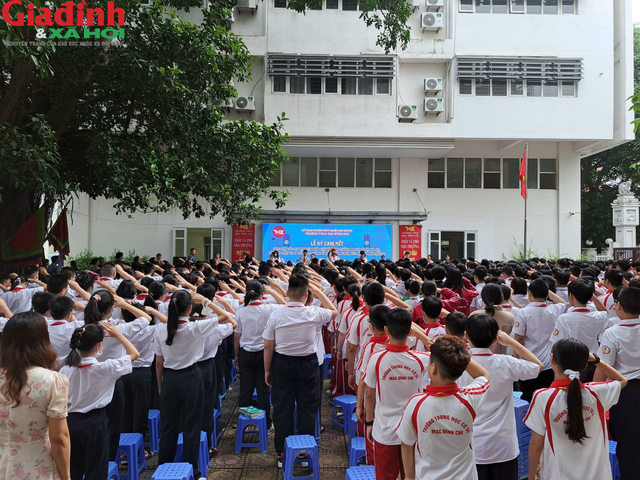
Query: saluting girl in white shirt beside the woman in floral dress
60 323 138 480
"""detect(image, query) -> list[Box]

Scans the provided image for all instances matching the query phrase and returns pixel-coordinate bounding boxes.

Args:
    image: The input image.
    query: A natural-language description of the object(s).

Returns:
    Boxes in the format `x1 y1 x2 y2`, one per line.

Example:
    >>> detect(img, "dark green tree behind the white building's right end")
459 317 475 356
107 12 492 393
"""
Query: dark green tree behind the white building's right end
581 26 640 251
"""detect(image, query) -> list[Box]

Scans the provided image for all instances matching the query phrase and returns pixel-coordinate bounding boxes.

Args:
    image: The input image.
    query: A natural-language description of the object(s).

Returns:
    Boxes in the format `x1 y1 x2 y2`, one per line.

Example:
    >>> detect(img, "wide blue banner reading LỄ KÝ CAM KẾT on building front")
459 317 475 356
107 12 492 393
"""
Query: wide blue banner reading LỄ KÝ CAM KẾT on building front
262 223 393 262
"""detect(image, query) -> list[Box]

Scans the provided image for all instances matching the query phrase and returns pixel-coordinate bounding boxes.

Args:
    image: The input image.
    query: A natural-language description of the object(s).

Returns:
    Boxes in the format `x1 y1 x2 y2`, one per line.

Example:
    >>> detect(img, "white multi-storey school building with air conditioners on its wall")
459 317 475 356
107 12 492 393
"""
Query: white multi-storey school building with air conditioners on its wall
70 0 633 259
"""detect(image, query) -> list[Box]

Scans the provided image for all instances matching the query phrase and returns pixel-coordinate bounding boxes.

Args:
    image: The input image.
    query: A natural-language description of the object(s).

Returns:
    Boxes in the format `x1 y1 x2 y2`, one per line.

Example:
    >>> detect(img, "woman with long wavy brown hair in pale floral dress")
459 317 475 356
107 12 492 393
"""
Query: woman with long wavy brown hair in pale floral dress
0 312 71 480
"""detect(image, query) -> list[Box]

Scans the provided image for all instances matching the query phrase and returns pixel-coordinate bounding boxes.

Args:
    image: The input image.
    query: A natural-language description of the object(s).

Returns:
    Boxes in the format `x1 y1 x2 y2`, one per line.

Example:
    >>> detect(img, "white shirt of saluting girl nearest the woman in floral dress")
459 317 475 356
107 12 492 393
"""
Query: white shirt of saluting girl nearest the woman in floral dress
60 355 132 413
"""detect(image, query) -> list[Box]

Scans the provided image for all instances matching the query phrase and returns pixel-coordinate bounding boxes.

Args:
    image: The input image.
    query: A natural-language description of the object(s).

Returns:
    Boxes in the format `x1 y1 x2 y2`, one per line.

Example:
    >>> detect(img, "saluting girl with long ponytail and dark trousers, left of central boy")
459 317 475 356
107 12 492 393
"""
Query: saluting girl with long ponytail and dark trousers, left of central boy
152 290 230 478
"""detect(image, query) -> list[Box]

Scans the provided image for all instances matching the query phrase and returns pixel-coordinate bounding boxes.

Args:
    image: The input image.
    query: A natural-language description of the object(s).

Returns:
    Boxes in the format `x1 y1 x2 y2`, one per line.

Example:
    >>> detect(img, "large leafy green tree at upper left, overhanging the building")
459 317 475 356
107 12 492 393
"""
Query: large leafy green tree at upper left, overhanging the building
0 0 410 249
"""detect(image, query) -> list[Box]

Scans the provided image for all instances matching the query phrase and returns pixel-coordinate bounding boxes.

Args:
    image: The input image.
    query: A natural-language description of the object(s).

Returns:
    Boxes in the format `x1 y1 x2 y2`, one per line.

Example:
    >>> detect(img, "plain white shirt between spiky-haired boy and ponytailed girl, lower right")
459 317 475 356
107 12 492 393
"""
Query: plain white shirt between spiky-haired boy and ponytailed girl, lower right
457 348 540 465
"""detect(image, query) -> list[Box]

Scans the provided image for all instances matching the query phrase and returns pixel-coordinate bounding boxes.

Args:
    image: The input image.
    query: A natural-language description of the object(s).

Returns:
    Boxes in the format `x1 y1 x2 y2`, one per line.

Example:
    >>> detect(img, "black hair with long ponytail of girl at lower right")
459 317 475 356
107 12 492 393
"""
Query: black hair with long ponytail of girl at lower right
552 340 589 444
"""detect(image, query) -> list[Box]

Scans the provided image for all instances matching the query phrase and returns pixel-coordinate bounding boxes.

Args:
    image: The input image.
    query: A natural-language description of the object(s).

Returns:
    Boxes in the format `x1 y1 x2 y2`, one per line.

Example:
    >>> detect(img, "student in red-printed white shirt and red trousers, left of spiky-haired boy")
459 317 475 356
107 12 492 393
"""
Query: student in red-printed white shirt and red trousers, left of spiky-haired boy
364 308 429 480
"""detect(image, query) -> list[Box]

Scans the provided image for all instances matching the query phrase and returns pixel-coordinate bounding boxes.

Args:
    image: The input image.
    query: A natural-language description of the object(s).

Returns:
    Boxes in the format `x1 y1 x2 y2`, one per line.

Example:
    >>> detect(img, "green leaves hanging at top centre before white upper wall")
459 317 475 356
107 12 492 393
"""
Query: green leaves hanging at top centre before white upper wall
287 0 411 53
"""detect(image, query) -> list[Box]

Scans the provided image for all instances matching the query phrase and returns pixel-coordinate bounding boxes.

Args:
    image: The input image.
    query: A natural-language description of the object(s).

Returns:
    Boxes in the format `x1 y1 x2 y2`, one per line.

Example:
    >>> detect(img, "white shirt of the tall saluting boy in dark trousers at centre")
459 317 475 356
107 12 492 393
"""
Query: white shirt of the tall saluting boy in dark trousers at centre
262 302 332 357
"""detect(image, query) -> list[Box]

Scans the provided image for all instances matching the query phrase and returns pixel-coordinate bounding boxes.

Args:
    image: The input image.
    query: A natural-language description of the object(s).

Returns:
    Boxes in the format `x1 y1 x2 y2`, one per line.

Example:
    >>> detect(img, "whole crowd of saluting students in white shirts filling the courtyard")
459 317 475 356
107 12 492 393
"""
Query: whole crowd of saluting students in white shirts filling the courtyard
0 251 640 480
